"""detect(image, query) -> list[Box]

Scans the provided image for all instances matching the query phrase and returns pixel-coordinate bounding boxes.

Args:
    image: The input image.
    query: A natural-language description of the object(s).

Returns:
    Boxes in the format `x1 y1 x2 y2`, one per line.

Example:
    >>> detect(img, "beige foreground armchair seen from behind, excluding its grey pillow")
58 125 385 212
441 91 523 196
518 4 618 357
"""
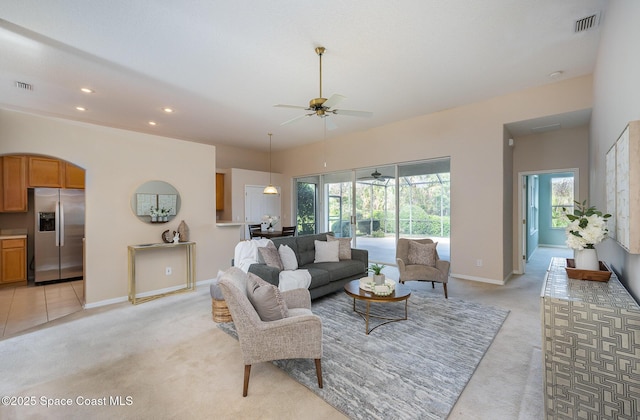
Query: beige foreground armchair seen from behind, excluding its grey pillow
219 267 322 397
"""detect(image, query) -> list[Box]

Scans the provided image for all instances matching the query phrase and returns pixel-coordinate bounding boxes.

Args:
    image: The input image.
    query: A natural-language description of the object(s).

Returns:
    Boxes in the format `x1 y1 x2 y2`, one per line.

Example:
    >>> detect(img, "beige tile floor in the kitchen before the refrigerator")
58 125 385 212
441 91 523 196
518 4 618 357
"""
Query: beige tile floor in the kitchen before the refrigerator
0 280 84 337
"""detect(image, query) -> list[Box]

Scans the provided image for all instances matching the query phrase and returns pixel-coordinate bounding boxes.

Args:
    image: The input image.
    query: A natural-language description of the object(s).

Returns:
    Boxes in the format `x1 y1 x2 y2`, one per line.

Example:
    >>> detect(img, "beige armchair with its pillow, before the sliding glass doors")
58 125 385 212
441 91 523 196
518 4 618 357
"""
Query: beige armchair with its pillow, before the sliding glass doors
396 238 450 299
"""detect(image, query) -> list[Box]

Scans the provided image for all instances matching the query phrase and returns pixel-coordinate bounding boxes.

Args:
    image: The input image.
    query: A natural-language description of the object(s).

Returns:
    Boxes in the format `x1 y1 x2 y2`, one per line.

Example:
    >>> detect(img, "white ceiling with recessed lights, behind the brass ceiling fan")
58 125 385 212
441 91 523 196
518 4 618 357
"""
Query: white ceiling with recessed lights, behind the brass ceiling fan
0 0 608 150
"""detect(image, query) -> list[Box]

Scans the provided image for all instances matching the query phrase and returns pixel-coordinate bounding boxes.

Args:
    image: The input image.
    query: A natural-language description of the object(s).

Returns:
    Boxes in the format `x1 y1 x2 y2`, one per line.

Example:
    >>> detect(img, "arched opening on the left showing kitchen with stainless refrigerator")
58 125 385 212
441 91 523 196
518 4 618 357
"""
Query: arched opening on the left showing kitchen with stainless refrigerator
0 154 85 336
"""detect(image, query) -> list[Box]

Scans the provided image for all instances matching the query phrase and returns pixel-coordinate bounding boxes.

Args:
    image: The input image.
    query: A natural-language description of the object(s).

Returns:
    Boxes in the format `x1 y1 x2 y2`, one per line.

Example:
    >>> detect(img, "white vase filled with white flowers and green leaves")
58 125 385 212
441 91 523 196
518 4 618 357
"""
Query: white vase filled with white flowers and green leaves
562 200 611 271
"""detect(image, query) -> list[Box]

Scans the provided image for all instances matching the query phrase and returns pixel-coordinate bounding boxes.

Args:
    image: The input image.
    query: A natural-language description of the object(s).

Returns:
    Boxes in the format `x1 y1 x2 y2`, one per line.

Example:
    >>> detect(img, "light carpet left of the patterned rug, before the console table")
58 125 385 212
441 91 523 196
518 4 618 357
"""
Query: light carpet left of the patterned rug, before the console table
0 286 342 419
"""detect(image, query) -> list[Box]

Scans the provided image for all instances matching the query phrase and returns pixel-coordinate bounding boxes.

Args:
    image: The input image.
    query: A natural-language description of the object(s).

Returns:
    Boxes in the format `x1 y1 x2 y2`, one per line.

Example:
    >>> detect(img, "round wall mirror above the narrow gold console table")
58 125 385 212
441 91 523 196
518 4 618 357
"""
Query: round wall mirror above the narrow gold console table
131 181 180 223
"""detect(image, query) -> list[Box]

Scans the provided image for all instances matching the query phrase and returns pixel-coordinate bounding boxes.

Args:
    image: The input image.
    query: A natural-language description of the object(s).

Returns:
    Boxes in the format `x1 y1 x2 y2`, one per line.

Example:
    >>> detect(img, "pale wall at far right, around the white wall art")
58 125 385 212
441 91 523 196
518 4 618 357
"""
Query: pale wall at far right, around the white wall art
589 0 640 300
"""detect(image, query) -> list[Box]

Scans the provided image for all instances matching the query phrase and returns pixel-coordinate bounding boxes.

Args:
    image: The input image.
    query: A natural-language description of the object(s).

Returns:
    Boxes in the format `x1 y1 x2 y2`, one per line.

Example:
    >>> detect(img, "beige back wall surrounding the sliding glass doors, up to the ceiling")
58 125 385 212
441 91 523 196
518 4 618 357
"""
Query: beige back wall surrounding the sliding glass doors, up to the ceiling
274 76 592 283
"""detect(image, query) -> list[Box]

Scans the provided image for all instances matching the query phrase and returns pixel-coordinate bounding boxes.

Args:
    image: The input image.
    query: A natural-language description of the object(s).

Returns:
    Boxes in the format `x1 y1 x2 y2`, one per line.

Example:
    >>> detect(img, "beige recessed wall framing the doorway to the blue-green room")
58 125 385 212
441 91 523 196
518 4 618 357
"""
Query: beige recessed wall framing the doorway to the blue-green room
512 126 589 267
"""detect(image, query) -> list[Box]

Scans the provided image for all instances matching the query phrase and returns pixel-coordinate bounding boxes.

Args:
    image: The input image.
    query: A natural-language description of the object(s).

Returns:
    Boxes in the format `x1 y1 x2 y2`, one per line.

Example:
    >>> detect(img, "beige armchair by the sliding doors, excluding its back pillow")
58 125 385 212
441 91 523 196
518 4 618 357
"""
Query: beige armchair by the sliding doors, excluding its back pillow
396 238 450 299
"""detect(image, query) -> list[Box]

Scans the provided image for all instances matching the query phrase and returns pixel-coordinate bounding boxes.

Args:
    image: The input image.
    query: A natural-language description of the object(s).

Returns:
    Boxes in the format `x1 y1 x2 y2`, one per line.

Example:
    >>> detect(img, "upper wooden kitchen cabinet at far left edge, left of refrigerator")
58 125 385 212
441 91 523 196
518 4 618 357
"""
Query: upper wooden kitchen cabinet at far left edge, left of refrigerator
0 156 27 212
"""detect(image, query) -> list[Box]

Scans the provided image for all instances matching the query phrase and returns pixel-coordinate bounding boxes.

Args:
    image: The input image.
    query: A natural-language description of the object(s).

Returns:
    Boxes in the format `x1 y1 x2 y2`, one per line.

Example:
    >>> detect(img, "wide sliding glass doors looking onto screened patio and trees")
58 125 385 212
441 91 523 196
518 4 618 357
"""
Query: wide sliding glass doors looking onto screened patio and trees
296 158 451 265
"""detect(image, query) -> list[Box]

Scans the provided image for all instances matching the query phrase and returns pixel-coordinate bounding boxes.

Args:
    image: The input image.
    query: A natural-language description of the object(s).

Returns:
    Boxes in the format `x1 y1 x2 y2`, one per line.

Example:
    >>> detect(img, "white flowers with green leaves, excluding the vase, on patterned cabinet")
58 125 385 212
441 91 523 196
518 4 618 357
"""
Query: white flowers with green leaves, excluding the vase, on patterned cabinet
562 201 611 249
